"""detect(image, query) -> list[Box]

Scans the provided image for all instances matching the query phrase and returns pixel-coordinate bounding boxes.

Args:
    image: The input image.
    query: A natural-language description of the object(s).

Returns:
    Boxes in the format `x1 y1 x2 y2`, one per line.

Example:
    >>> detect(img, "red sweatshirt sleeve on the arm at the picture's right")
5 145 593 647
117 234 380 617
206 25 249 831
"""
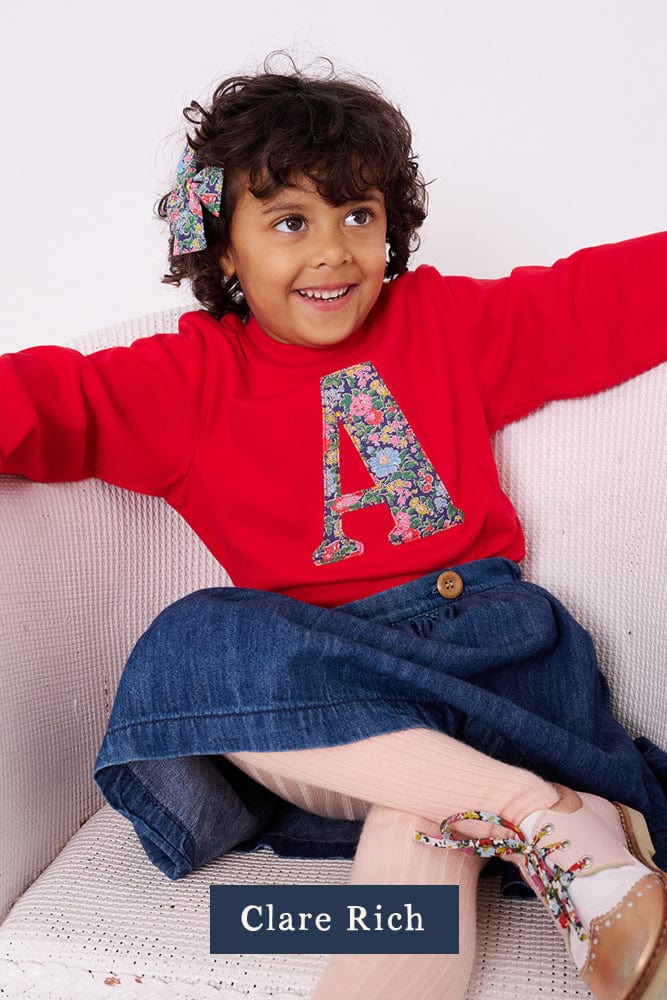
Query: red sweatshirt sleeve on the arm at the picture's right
428 232 667 431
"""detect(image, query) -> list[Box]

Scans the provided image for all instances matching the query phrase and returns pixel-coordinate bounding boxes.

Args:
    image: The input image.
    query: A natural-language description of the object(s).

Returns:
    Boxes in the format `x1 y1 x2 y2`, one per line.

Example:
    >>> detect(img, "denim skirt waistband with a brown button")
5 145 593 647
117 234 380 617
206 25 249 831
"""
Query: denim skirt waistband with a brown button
340 557 521 623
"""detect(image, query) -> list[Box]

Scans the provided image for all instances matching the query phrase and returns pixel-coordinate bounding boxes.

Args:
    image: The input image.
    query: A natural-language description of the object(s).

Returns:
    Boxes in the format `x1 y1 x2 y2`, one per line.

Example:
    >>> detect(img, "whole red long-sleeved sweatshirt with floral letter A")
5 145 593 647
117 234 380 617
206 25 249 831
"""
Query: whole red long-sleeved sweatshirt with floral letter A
0 233 667 606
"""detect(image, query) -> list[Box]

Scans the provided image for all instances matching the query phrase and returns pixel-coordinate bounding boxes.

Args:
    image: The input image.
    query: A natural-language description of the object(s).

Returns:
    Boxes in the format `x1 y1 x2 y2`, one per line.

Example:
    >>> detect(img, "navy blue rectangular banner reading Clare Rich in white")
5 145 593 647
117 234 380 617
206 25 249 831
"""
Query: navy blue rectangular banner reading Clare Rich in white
211 885 459 955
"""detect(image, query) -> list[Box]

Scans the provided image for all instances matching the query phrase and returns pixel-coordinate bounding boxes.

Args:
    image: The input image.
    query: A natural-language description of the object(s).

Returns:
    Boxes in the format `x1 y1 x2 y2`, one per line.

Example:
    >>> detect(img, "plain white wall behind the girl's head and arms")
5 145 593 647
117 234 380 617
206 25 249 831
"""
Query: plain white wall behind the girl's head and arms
0 0 667 350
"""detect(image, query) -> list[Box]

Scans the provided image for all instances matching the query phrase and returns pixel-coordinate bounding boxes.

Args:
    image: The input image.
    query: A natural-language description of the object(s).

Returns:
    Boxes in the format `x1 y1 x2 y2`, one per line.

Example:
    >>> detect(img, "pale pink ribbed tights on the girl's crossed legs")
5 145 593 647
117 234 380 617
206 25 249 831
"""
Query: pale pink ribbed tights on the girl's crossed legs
228 729 559 1000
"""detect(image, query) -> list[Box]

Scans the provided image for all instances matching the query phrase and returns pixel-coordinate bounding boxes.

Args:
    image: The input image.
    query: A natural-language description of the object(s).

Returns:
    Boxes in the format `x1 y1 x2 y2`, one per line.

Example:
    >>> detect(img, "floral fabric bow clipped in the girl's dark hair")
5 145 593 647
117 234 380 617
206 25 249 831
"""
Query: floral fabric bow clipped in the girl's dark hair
167 146 224 256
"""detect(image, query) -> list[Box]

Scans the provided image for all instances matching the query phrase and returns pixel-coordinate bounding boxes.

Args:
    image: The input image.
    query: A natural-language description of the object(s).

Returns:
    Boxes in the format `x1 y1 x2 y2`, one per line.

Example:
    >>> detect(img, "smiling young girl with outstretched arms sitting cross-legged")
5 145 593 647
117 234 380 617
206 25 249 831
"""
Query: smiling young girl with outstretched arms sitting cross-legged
0 64 667 1000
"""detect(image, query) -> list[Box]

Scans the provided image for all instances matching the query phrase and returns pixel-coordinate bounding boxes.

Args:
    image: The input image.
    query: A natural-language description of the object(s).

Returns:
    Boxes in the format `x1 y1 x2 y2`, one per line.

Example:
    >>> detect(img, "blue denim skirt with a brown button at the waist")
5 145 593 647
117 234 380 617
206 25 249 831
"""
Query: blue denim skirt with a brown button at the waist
95 559 667 878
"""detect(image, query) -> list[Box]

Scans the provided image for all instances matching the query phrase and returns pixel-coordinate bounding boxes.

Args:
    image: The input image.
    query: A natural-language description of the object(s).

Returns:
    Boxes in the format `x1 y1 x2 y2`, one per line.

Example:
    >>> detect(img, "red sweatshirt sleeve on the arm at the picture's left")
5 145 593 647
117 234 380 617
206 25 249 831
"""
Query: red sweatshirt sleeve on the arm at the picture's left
0 318 207 497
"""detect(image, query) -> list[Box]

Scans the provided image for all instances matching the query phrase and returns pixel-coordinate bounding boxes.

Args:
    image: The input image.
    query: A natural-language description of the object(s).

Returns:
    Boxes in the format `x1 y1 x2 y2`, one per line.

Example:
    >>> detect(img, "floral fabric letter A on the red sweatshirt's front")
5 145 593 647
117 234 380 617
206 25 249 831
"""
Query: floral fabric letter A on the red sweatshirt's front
313 362 463 566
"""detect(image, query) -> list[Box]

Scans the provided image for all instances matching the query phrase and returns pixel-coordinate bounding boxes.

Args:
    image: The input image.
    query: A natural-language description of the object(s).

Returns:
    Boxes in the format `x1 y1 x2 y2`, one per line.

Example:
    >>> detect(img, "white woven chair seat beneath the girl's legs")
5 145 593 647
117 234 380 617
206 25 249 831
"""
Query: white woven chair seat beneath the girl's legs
0 806 587 1000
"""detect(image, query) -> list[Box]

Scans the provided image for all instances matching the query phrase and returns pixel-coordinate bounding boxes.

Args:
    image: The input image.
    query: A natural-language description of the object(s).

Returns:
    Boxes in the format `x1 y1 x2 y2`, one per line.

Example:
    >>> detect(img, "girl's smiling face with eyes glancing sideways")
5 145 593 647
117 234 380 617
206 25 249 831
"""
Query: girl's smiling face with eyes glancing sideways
220 178 387 348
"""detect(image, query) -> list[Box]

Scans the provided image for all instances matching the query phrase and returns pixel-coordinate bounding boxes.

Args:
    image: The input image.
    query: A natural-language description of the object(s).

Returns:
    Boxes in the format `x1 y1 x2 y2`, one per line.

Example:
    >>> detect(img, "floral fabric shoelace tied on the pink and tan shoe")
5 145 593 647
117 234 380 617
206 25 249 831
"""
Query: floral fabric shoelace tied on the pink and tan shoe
415 809 590 941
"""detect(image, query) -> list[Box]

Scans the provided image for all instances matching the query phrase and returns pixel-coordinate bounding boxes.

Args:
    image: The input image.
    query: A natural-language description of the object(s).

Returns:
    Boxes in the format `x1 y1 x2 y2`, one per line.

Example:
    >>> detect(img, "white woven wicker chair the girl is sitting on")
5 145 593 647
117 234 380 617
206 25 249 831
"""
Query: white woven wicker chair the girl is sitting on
0 312 667 1000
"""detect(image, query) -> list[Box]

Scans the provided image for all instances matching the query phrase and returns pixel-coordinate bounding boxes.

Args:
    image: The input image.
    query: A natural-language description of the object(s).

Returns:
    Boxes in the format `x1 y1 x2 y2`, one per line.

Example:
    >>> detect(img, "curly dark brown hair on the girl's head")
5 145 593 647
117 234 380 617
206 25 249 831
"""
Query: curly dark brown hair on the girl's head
157 53 427 319
